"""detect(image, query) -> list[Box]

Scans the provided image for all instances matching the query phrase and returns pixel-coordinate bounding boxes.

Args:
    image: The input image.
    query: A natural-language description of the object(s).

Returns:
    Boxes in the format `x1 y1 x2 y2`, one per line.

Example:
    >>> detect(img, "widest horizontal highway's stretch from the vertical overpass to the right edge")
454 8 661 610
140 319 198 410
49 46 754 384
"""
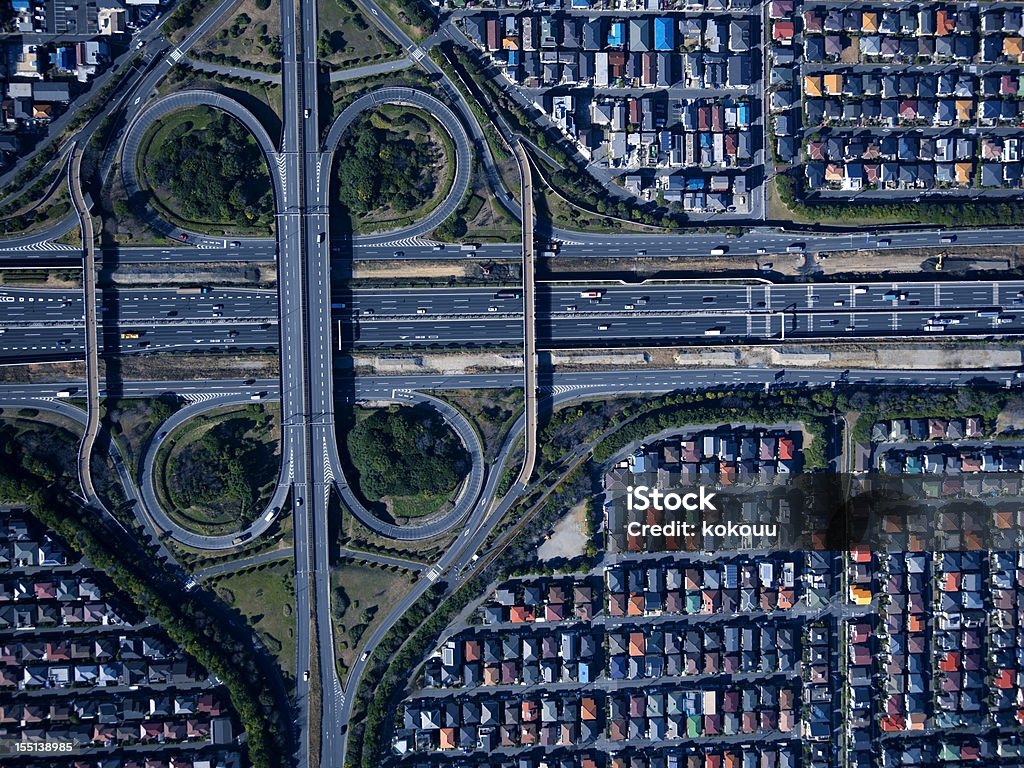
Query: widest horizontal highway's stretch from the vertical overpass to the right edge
350 281 1024 347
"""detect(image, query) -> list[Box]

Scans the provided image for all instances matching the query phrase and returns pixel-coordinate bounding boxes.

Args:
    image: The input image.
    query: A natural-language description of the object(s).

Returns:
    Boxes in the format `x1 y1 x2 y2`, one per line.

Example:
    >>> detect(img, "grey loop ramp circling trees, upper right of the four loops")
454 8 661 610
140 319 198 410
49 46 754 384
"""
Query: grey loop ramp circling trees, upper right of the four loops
316 87 473 242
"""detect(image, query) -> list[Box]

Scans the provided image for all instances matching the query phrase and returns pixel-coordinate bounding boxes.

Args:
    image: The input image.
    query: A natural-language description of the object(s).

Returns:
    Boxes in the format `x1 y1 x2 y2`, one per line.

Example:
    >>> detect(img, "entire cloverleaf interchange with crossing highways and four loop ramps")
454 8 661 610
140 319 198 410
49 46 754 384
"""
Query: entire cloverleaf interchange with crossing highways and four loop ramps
6 0 1024 768
